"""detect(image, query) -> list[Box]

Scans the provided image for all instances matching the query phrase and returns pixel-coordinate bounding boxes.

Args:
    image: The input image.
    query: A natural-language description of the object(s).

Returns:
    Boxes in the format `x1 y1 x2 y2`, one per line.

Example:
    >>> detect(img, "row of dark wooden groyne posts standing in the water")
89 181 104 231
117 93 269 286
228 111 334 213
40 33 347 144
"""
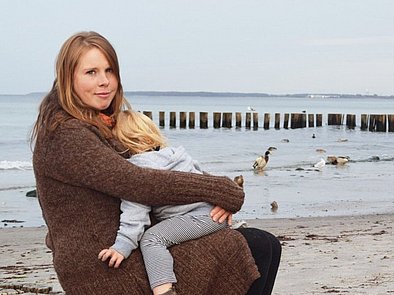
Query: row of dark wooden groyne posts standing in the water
143 111 394 132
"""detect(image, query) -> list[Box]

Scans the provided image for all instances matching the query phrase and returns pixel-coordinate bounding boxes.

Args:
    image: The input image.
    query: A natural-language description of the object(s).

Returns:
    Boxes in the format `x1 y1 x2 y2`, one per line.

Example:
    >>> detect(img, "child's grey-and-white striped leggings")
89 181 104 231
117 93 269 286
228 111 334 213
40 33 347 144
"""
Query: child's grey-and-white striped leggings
140 214 227 289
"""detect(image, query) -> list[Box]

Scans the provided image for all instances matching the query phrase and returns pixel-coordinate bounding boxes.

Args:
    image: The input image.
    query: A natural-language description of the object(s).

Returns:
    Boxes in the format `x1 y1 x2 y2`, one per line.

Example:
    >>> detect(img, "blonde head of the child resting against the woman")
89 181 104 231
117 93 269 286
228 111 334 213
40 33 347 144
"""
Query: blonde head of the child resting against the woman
112 110 166 154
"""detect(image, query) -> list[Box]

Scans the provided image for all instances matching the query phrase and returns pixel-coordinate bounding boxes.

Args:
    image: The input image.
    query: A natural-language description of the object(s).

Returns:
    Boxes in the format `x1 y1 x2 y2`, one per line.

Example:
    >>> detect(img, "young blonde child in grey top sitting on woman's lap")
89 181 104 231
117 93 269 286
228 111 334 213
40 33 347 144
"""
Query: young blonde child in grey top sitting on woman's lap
99 111 234 295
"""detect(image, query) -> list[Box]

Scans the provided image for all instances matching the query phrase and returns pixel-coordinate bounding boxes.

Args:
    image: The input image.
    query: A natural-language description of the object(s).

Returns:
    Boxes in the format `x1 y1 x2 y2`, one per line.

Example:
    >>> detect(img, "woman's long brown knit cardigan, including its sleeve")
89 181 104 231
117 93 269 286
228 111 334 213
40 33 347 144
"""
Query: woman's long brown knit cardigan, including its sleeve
33 114 259 295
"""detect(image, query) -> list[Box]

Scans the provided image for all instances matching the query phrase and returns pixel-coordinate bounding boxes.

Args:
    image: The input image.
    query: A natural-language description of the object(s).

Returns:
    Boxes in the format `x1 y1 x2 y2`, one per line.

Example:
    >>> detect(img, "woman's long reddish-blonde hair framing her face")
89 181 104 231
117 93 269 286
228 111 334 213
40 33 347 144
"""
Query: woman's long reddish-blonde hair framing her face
31 32 131 142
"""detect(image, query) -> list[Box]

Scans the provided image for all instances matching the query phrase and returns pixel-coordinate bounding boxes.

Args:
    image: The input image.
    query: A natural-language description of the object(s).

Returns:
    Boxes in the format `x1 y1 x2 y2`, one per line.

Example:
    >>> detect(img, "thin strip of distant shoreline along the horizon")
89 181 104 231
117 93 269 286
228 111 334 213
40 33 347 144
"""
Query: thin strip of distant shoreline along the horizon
0 91 394 99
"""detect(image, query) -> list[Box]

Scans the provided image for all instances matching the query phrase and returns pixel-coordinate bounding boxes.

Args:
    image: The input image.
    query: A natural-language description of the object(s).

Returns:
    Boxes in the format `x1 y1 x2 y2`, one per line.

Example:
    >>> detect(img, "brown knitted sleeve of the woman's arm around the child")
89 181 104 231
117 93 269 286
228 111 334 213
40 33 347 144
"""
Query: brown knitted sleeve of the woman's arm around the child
40 120 244 212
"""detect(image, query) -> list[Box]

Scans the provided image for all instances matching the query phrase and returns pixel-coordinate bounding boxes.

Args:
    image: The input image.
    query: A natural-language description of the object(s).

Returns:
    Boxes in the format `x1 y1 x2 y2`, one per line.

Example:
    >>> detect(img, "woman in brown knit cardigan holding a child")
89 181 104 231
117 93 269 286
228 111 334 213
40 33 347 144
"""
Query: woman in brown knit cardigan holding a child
32 32 280 295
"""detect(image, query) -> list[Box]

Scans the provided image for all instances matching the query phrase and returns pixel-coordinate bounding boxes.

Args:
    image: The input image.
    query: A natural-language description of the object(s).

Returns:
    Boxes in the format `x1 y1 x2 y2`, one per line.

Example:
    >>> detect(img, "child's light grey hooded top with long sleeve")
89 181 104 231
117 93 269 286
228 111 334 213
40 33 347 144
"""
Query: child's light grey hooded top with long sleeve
111 146 213 258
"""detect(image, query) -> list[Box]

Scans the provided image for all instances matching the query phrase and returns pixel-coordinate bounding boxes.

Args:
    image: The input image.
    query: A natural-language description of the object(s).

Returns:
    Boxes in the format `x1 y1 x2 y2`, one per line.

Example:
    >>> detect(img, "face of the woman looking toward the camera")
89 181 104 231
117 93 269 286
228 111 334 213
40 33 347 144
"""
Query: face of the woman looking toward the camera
73 47 118 111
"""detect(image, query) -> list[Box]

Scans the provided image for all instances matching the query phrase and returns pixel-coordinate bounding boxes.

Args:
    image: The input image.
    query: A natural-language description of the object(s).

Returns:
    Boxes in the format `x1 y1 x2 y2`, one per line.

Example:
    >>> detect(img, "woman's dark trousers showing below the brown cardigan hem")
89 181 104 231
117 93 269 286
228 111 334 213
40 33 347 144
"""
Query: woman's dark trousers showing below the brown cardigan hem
237 228 282 295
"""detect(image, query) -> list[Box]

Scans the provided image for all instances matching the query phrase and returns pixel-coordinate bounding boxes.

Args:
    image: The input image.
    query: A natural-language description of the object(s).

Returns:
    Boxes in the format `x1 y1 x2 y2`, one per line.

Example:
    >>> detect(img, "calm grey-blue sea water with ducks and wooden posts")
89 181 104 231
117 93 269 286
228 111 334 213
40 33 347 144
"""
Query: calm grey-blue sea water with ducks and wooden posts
0 94 394 226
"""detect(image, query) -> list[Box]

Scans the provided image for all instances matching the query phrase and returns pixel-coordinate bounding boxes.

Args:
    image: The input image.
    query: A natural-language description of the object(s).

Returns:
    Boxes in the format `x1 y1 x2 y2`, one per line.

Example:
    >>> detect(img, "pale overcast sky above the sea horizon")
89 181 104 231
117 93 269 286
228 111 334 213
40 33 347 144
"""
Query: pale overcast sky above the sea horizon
0 0 394 95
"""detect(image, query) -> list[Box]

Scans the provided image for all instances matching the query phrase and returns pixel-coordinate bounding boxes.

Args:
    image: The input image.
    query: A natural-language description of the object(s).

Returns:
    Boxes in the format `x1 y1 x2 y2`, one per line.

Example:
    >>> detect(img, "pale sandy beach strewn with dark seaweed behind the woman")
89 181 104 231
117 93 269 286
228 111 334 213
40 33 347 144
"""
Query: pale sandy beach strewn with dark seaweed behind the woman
0 213 394 295
